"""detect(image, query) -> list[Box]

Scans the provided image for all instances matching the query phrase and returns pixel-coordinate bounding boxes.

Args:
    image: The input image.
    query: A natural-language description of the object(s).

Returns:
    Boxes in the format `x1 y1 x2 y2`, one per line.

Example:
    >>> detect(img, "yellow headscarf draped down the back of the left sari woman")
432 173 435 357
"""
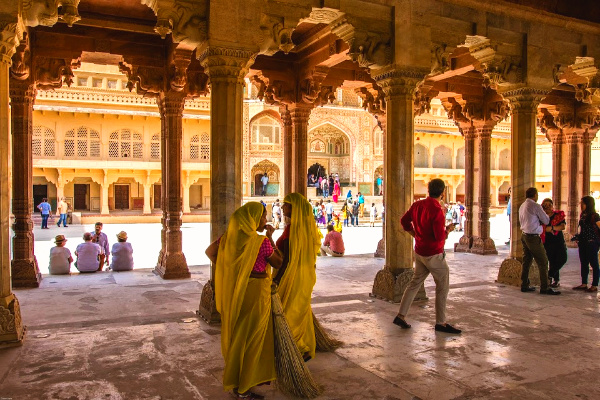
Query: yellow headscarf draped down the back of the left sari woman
215 201 265 359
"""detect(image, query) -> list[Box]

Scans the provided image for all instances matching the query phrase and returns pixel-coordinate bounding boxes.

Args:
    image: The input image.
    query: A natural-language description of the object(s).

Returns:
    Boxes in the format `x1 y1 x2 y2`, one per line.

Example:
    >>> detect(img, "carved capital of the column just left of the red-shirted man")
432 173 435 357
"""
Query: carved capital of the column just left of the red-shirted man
371 66 429 97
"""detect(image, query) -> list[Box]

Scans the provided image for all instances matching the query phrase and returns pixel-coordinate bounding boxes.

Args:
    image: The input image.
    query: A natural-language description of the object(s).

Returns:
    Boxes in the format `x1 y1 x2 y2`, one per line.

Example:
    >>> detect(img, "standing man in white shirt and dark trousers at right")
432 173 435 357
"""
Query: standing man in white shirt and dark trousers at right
519 187 560 295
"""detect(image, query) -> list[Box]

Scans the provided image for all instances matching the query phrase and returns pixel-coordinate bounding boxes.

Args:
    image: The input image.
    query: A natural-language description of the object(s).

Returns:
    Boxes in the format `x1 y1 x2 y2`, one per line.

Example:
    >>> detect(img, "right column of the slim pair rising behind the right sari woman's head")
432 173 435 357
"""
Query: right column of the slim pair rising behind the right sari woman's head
288 103 313 197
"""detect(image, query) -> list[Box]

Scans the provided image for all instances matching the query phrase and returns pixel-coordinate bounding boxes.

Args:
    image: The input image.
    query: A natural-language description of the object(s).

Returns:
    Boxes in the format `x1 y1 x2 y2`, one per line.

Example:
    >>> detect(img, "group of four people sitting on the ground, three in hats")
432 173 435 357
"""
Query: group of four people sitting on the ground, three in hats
48 222 133 275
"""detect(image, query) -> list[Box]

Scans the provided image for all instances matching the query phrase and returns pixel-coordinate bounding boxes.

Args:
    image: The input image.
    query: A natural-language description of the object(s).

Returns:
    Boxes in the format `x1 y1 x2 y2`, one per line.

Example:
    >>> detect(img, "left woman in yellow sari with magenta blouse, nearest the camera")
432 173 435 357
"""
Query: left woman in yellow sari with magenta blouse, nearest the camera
206 202 282 399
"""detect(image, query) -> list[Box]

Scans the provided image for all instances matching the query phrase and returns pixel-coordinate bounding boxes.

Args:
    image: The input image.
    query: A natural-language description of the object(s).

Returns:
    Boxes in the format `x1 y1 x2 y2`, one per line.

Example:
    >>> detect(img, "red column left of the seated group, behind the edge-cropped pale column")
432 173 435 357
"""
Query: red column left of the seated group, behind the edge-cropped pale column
10 78 42 287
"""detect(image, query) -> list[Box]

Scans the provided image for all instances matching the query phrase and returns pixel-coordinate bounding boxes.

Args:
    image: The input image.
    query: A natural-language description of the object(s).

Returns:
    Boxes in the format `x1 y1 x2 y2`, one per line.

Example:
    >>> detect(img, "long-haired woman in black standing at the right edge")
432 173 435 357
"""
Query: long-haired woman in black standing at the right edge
573 196 600 292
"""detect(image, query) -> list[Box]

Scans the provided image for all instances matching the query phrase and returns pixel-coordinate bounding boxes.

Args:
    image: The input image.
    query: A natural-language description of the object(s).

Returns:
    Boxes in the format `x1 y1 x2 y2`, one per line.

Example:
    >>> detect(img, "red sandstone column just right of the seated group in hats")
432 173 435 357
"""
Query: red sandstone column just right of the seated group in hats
155 92 190 279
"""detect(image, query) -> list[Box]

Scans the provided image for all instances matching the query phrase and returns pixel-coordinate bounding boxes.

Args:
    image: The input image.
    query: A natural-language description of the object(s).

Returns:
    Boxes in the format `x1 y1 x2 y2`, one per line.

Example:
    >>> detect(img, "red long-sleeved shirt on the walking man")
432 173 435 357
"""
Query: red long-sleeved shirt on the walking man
400 197 448 257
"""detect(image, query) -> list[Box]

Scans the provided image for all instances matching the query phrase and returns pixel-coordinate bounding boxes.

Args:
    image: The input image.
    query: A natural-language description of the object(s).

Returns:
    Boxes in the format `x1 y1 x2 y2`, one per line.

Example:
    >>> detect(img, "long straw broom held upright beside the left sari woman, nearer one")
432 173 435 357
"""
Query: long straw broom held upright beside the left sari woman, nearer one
271 283 321 399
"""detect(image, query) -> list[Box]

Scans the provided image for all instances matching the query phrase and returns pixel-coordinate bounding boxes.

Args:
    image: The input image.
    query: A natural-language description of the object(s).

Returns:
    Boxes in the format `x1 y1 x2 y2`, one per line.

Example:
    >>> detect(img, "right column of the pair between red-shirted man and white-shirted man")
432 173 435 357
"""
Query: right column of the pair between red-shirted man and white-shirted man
471 123 498 255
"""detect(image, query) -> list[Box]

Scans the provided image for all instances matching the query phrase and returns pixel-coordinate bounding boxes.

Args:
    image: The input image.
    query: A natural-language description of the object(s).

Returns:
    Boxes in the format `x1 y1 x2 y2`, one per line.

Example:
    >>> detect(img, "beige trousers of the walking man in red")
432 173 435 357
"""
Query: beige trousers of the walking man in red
398 253 450 324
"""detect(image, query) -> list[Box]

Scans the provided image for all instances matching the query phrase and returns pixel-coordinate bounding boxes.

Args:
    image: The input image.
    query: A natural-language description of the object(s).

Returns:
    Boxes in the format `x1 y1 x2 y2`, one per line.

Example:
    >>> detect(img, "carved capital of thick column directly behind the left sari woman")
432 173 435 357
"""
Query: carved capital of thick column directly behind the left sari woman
197 44 258 83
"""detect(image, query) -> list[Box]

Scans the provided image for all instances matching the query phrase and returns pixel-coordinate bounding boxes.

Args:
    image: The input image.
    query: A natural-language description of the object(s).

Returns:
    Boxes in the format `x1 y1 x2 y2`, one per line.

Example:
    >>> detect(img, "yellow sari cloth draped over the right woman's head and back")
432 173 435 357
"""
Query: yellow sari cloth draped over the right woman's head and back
279 193 321 358
